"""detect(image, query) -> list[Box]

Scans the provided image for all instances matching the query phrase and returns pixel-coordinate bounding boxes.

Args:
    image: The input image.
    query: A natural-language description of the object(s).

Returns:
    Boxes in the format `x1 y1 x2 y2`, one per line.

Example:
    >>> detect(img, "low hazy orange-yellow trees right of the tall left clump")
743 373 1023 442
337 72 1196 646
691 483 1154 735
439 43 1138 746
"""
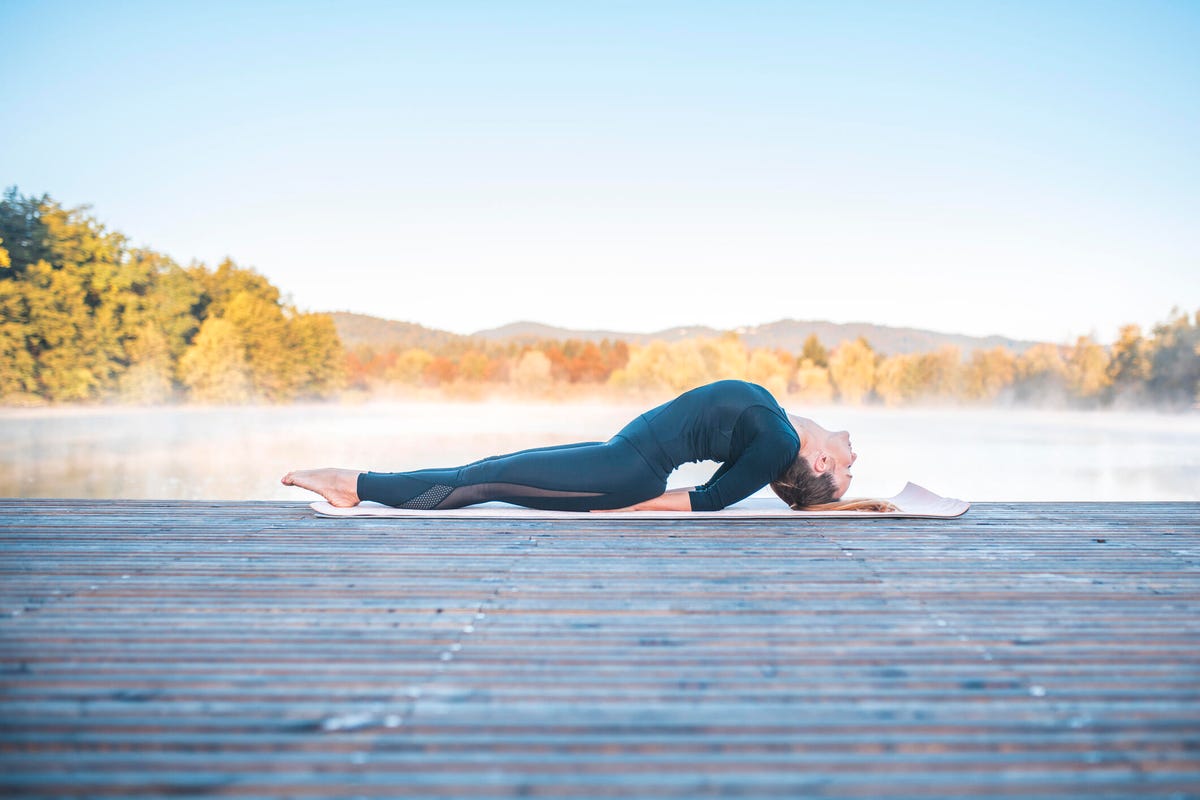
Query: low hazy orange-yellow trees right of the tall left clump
347 312 1200 408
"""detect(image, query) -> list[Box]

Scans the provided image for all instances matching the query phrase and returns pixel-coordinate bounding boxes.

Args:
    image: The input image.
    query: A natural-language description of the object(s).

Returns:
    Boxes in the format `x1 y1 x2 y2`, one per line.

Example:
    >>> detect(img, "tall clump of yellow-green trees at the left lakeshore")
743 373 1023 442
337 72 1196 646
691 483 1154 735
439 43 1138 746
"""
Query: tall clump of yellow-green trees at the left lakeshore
0 188 346 404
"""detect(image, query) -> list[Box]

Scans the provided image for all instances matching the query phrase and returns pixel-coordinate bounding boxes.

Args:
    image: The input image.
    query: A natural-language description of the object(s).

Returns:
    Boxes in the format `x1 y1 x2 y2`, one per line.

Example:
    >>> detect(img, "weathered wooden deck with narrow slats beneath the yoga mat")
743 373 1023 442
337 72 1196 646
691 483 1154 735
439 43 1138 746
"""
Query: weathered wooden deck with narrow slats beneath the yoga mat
0 500 1200 798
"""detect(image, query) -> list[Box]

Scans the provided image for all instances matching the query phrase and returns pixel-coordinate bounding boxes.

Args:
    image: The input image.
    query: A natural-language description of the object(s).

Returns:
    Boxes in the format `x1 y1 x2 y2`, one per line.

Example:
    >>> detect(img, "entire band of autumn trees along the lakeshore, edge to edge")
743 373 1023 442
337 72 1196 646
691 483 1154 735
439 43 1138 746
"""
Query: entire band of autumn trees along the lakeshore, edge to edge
0 188 1200 408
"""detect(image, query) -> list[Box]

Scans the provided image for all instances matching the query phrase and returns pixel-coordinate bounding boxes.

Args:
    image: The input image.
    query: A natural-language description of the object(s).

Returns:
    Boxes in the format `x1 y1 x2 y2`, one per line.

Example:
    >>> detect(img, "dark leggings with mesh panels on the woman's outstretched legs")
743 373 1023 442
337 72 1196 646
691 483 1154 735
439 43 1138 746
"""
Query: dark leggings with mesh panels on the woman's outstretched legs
356 437 667 511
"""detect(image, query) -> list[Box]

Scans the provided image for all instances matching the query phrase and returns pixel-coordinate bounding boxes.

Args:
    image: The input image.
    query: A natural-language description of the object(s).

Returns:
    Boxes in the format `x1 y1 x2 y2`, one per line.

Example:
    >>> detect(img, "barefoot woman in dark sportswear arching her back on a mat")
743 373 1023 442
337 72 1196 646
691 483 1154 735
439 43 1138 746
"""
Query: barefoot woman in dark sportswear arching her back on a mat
283 380 889 511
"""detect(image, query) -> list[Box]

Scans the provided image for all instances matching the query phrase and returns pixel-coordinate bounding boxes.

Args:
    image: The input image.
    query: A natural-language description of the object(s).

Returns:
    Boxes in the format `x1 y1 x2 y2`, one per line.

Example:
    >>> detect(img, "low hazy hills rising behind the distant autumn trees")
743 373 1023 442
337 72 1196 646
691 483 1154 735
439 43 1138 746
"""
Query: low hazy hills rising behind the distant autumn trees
331 312 1036 356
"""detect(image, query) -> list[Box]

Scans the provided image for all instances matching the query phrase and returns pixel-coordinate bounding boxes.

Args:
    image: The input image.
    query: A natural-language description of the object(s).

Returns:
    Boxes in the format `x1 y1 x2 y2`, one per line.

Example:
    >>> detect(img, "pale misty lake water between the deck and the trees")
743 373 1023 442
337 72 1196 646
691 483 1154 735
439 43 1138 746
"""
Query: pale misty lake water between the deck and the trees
0 402 1200 501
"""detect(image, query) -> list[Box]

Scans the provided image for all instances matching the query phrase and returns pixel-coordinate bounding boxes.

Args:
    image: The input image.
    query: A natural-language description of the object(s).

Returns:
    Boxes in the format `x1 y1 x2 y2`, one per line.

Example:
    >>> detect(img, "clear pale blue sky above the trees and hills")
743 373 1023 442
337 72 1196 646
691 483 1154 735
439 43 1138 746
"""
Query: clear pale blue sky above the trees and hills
0 0 1200 341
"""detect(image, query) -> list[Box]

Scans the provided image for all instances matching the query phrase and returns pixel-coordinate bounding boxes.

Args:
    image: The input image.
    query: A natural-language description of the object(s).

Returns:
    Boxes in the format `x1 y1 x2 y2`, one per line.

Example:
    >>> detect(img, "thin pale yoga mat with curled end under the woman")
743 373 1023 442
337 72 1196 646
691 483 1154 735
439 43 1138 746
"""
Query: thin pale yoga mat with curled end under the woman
311 482 971 521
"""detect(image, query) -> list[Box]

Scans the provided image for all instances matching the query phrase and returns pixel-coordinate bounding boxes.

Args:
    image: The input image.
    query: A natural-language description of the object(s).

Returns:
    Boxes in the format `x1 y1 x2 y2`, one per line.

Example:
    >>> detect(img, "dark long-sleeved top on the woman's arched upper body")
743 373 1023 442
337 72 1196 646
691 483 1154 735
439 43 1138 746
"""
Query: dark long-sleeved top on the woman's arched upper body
642 380 800 511
